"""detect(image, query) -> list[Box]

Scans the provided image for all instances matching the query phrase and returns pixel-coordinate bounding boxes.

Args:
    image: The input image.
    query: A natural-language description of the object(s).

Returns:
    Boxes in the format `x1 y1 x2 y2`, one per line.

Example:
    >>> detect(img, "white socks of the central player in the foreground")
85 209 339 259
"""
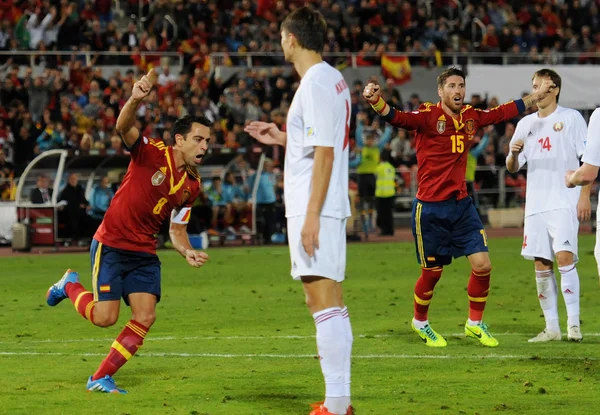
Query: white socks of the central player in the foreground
313 307 353 415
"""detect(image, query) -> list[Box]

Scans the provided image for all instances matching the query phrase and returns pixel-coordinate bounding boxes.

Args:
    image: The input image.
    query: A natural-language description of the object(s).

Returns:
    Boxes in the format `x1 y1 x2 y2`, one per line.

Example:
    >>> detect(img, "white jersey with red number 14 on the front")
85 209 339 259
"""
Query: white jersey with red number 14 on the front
511 106 587 216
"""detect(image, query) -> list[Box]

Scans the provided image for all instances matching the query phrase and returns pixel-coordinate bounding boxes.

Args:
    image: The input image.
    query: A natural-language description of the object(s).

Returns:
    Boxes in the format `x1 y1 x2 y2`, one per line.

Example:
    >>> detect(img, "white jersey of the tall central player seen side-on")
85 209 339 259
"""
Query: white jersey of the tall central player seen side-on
284 62 351 218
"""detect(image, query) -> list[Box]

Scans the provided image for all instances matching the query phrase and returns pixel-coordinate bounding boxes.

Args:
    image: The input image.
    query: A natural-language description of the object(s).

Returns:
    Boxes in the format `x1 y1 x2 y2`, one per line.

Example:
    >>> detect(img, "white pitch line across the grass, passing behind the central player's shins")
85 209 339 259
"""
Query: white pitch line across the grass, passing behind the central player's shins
0 352 599 361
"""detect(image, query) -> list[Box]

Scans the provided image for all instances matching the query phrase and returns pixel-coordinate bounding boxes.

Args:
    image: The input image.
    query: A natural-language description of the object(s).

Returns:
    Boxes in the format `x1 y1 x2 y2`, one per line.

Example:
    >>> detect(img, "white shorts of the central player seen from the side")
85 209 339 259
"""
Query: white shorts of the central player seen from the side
287 216 346 282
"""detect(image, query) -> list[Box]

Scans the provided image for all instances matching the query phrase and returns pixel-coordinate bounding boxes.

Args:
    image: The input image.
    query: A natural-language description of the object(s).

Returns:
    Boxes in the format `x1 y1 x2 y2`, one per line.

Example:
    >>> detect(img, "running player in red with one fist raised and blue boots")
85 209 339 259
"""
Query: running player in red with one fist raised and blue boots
47 70 210 393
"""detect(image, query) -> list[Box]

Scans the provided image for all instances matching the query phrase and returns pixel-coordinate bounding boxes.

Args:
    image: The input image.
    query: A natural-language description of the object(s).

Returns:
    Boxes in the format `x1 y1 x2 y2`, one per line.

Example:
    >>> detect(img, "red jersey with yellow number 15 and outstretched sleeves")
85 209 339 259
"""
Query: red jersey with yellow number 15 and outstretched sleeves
385 102 519 202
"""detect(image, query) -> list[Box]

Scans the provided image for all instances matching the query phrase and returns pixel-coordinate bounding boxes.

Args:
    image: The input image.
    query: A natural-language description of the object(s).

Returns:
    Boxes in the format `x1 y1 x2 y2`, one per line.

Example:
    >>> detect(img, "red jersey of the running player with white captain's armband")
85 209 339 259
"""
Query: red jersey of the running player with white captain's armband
94 136 200 254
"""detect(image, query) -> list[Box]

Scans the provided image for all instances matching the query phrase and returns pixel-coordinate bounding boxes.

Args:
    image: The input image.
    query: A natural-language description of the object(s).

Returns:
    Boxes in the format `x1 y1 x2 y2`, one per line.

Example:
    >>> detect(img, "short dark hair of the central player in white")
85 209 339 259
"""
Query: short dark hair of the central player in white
281 6 327 53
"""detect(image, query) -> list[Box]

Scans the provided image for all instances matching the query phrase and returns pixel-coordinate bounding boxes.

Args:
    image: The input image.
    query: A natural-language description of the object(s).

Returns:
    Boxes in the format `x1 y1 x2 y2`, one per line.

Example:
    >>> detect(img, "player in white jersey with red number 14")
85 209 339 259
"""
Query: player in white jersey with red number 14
506 69 591 342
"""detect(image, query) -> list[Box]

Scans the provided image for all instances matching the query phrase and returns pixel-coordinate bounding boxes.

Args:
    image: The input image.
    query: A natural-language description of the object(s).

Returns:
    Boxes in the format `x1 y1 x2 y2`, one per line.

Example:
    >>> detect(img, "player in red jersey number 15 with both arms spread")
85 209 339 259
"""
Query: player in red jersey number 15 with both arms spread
363 68 552 347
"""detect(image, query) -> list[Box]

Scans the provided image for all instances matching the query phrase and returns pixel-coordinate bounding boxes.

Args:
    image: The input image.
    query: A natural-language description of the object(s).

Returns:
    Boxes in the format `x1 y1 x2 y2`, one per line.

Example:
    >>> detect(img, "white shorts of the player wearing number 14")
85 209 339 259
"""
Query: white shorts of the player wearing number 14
521 209 579 262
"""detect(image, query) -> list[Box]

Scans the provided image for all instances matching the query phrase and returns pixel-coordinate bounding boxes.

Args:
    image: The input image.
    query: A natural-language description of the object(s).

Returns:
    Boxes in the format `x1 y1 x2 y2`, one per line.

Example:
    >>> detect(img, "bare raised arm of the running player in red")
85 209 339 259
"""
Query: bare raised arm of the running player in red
116 69 158 149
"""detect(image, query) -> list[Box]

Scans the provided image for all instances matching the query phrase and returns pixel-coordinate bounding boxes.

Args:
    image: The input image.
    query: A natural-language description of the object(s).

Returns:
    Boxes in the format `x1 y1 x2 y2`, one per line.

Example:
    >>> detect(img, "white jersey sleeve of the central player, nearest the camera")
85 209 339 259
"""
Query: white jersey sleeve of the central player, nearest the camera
302 81 335 147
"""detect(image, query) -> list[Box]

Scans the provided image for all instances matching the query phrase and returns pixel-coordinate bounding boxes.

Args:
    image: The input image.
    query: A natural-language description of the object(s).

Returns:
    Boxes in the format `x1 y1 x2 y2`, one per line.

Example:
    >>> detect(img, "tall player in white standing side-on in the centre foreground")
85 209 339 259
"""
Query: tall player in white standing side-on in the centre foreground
245 7 353 415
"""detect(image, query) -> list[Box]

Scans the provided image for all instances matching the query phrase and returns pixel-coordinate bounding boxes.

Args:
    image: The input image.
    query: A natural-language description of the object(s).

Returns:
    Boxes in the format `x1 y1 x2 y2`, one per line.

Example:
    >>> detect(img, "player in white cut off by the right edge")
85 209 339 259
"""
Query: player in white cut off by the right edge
565 108 600 278
